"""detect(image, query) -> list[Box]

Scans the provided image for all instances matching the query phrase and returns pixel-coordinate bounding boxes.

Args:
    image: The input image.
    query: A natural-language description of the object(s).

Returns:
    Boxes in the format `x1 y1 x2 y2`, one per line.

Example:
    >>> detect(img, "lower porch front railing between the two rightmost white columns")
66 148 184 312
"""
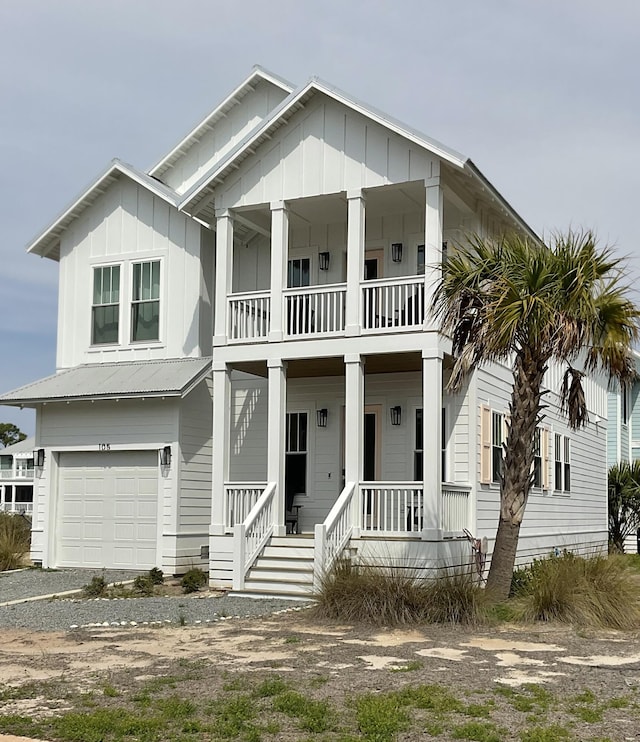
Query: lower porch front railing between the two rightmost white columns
360 482 424 535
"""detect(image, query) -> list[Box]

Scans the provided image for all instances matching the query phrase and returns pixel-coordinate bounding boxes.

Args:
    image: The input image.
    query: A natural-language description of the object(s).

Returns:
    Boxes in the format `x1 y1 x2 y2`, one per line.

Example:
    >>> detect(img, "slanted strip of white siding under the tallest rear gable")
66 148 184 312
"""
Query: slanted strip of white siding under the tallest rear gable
162 80 287 194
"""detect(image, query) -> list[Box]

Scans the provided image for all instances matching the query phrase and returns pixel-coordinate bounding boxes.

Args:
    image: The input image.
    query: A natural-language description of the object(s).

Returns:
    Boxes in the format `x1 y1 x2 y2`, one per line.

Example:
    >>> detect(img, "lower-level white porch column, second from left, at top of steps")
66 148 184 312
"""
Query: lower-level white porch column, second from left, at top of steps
267 358 287 536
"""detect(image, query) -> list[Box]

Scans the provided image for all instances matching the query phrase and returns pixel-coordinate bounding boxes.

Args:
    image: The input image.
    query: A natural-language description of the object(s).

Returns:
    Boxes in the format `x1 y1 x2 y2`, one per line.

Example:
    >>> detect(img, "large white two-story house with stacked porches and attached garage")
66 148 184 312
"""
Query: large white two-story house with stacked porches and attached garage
0 68 607 593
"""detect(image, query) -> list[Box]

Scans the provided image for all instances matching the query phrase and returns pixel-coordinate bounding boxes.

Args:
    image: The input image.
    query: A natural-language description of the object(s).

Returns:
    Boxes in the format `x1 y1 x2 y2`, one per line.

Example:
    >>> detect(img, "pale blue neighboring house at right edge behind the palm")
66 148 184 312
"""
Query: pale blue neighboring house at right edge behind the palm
607 351 640 553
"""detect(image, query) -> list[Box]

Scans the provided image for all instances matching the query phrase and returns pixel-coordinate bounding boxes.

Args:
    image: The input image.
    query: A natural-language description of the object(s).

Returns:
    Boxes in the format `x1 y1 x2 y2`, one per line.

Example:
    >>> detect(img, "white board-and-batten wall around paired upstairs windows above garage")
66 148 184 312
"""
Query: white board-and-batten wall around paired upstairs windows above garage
56 176 213 368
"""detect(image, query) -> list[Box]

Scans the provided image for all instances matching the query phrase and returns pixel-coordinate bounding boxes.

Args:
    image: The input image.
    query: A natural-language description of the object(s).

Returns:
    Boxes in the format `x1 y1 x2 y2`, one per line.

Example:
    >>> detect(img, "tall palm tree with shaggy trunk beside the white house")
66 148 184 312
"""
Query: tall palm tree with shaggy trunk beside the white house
433 231 640 599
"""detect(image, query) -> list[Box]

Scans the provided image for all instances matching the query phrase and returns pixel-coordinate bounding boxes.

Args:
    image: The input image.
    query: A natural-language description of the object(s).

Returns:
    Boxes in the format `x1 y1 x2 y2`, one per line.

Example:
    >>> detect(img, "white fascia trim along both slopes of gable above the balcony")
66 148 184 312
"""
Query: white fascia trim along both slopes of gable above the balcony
178 79 465 210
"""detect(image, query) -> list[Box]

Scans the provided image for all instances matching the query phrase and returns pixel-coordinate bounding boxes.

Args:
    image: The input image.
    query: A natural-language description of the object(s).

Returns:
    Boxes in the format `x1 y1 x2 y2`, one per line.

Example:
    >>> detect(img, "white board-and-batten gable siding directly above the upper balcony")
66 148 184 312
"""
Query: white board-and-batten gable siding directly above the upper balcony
220 94 439 208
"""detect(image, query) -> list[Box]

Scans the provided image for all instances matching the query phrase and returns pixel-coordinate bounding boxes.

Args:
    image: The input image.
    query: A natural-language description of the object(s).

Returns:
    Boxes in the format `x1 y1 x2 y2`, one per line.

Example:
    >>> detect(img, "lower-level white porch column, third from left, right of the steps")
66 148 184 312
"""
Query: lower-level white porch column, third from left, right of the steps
344 353 364 537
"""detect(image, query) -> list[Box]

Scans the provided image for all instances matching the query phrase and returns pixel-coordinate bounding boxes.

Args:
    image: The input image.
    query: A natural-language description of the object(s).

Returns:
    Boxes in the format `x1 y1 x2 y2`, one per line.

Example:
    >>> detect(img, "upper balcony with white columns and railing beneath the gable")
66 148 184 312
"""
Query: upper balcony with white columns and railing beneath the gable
214 181 474 345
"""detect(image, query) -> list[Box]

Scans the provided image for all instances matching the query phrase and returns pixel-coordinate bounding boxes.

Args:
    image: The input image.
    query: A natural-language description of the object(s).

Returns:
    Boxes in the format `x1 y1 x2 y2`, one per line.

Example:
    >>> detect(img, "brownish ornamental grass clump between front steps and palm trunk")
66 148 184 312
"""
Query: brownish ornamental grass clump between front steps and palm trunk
316 560 486 626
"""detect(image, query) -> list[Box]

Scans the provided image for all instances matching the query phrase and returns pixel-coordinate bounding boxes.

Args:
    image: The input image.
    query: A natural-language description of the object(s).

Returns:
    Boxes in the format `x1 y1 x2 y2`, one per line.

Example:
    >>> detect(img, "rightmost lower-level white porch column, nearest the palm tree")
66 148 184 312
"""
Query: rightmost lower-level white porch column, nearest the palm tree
422 348 443 540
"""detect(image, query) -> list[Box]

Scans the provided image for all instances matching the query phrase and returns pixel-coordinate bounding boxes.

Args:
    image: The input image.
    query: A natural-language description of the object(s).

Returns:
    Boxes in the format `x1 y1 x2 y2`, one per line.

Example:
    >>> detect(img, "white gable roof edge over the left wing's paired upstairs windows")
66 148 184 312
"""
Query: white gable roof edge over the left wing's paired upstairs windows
27 159 178 260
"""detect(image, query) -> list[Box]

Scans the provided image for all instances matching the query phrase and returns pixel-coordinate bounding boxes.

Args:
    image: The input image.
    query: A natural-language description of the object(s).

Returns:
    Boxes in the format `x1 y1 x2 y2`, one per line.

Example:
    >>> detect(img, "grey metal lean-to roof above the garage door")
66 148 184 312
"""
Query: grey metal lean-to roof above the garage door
0 358 211 405
